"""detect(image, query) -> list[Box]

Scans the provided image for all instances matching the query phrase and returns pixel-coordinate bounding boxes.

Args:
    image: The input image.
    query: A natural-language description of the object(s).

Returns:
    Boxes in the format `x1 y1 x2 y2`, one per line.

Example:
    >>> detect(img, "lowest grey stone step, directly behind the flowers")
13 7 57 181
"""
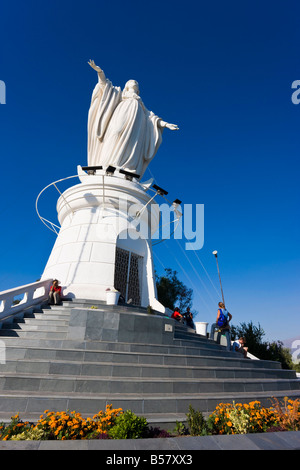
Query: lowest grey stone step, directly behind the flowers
0 390 300 429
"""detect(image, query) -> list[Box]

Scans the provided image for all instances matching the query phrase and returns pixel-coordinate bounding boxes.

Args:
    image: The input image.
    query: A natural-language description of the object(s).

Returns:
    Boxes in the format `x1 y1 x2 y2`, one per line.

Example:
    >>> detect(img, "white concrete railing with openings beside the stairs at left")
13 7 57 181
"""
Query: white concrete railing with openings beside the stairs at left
0 279 52 321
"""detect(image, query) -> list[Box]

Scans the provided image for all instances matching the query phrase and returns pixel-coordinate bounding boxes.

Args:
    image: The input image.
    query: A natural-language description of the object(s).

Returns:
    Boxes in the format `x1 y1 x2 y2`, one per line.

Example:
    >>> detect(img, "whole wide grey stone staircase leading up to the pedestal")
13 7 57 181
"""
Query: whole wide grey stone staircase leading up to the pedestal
0 300 300 429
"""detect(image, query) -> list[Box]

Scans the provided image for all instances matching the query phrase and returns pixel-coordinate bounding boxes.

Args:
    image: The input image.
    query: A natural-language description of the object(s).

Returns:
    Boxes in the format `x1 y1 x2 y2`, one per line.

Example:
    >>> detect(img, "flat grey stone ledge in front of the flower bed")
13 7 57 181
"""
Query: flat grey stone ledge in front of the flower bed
0 431 300 455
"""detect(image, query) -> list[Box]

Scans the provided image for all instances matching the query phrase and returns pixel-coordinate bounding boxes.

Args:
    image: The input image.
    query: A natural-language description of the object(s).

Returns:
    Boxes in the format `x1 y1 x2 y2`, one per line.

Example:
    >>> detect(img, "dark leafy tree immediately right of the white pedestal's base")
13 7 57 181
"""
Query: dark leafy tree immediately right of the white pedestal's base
156 268 193 311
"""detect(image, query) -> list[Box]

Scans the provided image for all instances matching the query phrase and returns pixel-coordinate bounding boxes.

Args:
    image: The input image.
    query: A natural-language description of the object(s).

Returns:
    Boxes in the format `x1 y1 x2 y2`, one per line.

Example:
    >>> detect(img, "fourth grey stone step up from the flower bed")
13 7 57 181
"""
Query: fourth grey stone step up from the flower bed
4 334 281 370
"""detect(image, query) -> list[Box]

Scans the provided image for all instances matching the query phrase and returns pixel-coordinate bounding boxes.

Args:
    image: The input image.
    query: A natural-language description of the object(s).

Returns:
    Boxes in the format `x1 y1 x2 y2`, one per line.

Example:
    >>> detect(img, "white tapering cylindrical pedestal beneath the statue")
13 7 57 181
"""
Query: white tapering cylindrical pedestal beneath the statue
42 174 165 311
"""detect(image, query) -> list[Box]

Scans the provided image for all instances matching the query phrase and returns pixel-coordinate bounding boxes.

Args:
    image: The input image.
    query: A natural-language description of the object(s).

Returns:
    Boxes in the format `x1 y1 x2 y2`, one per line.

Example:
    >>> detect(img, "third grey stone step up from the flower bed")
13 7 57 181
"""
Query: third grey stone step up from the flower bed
0 357 296 380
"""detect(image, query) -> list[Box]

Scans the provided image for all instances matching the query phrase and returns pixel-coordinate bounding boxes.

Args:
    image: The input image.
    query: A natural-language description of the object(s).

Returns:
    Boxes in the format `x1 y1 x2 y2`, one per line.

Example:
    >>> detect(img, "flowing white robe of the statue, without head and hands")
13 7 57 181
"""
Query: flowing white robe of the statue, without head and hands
88 80 162 176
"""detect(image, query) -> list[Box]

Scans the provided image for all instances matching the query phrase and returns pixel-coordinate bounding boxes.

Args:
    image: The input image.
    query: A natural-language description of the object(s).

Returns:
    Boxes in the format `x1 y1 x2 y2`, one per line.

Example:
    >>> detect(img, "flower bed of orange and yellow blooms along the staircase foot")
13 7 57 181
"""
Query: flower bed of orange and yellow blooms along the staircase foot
0 397 300 441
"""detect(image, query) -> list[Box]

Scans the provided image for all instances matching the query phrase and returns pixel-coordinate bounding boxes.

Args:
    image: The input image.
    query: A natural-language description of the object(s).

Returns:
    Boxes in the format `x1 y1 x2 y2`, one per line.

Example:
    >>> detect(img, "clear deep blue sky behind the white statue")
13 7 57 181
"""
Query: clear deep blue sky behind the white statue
0 0 300 341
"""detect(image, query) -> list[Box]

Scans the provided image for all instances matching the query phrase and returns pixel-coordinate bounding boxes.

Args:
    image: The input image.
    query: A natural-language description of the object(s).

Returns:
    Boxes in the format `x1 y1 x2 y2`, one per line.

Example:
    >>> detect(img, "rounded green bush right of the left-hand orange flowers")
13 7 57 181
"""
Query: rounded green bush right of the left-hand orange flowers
108 410 147 439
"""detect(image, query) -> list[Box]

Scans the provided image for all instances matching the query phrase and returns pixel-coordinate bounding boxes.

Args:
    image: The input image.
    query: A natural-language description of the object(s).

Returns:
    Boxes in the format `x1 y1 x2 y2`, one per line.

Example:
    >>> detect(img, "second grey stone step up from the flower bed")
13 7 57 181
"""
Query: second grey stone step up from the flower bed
0 372 300 396
